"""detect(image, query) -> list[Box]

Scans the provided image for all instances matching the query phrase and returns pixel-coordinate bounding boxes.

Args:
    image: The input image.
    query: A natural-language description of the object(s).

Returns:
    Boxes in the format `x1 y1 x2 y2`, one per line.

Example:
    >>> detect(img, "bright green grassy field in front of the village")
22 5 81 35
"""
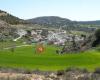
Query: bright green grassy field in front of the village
0 46 100 70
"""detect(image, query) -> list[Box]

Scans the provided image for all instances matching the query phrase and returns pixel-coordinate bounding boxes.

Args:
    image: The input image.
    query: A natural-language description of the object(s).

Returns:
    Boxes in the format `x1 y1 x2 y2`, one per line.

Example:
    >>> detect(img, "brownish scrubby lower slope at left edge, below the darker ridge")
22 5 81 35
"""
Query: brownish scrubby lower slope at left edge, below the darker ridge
0 20 17 38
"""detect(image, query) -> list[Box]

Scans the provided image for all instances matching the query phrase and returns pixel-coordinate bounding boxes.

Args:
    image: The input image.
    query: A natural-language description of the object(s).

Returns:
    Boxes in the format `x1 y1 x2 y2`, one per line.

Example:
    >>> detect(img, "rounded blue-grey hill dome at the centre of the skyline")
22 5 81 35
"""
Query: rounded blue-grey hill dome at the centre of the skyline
27 16 77 27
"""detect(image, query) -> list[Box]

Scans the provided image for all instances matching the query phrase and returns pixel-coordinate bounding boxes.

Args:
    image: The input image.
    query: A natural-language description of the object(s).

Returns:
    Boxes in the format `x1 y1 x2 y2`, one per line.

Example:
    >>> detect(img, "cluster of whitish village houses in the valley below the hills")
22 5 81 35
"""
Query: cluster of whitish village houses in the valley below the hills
14 29 84 45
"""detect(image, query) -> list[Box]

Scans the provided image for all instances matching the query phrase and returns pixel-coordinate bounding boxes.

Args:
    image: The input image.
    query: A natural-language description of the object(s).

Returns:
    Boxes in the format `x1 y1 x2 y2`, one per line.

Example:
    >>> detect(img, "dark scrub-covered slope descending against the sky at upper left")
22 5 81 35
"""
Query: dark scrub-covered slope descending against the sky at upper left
0 10 26 24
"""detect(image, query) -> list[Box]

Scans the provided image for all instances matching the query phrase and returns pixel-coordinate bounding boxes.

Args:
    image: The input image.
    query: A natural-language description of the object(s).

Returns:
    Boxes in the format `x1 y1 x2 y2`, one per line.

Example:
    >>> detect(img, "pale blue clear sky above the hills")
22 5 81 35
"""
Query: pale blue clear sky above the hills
0 0 100 21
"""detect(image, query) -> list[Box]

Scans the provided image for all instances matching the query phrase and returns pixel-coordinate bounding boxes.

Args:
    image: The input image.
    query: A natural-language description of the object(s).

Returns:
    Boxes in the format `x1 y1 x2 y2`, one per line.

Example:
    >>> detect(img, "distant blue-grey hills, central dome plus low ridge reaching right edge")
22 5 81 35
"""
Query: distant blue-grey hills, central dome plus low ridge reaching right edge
26 16 100 28
